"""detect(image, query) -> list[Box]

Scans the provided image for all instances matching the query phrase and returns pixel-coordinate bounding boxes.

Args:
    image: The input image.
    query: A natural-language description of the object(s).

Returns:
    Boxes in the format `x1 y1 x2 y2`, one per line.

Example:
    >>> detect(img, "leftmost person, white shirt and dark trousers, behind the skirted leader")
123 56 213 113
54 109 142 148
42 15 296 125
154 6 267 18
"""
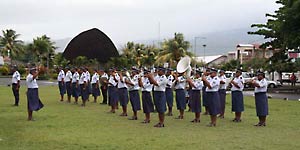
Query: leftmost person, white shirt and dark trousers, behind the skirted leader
11 66 21 106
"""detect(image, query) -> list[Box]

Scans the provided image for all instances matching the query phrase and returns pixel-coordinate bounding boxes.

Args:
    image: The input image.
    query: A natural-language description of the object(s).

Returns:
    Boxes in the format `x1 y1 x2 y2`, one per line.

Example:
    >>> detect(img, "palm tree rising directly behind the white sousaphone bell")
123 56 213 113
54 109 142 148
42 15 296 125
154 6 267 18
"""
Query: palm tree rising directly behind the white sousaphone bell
156 33 193 66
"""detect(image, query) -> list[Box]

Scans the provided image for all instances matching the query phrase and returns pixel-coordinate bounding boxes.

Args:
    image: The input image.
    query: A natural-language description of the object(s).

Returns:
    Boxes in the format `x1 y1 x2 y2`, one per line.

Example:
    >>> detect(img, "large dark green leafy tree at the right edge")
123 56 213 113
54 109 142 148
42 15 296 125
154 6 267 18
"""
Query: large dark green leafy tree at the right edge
248 0 300 74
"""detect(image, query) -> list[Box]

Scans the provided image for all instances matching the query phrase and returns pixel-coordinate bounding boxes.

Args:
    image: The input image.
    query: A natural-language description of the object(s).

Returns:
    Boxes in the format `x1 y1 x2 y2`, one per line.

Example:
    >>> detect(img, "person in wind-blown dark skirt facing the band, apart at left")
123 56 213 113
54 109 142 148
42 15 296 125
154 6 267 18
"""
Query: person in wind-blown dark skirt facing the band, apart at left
26 68 44 121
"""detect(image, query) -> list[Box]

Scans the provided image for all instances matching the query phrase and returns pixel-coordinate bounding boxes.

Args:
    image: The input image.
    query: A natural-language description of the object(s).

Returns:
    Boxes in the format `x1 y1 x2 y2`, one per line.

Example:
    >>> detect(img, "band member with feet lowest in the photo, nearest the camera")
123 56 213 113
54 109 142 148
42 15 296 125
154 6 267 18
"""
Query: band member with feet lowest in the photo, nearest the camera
148 67 168 128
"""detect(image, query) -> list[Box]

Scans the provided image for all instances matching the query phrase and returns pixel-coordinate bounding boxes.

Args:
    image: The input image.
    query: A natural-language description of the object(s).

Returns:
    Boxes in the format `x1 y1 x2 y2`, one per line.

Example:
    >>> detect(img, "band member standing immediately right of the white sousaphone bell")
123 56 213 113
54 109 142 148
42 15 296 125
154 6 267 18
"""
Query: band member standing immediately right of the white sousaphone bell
187 71 203 123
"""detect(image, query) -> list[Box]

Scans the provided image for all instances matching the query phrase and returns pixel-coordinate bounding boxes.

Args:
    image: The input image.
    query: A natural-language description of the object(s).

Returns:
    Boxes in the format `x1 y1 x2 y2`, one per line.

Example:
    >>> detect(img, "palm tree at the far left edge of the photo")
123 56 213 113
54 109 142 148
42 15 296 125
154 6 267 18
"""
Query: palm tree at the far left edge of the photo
0 29 23 59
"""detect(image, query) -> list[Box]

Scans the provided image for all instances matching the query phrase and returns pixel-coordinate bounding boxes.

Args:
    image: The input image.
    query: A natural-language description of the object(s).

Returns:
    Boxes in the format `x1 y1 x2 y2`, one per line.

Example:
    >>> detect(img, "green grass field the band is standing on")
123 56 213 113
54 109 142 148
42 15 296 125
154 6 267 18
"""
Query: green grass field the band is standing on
0 87 300 150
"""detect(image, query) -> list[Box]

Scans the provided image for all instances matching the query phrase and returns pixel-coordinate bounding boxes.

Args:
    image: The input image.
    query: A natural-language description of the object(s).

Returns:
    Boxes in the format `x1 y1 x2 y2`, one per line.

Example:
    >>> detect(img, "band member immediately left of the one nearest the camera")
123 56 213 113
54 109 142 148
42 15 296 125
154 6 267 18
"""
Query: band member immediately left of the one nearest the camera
139 70 154 123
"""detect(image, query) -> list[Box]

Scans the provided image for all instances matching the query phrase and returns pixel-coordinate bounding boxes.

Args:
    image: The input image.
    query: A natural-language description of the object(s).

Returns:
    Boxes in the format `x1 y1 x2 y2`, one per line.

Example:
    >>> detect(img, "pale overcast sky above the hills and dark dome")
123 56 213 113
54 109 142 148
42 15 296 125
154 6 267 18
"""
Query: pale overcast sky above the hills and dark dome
0 0 279 43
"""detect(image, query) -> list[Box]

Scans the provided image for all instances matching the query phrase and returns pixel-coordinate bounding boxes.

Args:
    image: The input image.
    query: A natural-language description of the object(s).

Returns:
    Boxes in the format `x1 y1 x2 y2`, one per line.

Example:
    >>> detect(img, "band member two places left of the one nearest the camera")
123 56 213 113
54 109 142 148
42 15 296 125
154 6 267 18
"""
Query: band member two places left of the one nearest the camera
129 68 141 120
